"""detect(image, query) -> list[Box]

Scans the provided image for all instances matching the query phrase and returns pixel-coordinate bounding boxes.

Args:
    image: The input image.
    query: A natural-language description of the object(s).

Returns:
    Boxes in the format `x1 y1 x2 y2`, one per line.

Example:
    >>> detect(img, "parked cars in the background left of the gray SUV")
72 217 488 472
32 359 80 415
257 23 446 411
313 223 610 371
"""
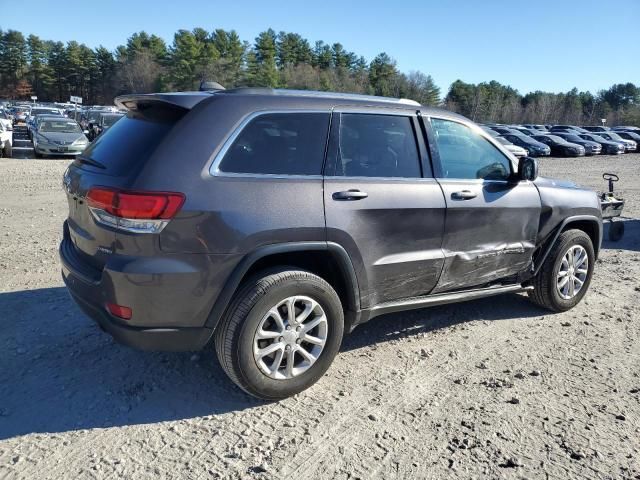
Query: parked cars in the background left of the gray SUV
0 104 124 158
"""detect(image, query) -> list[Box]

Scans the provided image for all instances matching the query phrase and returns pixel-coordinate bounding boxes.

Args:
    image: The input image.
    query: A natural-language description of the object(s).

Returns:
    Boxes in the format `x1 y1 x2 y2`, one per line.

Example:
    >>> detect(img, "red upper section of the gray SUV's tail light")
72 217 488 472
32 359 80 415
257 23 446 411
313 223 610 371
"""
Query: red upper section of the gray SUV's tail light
87 187 185 220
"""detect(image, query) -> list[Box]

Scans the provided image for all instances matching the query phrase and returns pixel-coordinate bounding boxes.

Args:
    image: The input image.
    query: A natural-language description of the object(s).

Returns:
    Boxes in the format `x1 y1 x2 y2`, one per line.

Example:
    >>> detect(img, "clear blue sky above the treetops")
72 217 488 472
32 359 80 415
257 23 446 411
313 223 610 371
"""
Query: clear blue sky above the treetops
0 0 640 95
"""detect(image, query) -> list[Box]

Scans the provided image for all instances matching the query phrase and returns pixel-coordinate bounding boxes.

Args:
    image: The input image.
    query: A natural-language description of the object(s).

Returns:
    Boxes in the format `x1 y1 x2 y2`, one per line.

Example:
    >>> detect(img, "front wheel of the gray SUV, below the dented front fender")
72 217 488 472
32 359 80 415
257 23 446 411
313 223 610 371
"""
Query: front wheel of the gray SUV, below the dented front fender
529 230 595 312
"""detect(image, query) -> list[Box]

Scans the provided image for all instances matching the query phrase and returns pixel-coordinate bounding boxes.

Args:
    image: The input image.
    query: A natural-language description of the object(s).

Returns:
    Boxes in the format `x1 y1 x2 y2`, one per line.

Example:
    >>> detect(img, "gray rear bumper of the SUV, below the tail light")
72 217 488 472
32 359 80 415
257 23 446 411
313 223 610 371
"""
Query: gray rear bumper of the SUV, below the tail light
59 223 240 351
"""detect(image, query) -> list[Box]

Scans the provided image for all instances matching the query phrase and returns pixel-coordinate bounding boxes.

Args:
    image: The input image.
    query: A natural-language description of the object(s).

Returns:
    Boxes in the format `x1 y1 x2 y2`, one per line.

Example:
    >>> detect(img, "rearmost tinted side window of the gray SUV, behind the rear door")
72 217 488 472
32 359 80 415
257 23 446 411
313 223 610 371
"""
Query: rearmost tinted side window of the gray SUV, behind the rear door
219 112 330 175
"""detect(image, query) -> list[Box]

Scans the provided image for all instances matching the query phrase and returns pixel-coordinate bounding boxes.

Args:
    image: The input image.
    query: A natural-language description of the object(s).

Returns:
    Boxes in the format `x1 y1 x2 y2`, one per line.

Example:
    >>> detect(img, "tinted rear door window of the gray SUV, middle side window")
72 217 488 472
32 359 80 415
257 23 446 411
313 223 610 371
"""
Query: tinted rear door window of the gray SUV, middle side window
336 113 422 178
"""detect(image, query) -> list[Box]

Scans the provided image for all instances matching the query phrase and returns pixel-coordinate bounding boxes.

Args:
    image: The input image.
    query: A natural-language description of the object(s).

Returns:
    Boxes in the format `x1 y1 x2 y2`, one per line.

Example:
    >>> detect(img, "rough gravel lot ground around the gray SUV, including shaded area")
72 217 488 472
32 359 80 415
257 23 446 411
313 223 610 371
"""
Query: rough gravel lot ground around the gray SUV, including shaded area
0 149 640 480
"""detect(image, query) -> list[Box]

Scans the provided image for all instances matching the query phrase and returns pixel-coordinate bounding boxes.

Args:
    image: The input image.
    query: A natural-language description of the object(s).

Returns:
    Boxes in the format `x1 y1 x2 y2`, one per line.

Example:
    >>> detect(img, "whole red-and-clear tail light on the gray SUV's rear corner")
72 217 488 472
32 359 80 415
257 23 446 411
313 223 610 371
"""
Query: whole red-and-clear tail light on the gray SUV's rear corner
87 187 185 233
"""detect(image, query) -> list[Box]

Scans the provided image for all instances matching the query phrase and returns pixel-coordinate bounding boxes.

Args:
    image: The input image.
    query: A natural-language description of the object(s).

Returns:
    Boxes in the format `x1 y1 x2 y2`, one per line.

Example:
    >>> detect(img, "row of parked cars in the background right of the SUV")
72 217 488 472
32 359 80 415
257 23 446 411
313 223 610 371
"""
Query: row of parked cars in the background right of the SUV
481 123 640 157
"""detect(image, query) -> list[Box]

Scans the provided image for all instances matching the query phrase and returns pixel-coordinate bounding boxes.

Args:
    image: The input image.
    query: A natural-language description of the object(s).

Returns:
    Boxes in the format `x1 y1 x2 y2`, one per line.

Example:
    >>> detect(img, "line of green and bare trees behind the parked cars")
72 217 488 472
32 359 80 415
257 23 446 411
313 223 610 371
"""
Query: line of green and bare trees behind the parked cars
0 28 640 124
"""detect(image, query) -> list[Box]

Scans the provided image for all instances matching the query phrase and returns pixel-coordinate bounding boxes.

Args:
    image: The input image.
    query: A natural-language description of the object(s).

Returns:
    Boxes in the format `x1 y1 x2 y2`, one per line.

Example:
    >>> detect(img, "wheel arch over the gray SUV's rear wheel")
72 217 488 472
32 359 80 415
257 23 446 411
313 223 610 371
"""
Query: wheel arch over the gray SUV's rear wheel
205 242 360 332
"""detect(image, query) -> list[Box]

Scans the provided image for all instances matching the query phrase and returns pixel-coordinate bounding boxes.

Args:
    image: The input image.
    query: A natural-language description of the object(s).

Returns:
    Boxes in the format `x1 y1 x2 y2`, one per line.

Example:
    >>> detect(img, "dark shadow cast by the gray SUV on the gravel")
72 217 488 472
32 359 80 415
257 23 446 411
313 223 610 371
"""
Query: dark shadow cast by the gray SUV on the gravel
0 287 544 440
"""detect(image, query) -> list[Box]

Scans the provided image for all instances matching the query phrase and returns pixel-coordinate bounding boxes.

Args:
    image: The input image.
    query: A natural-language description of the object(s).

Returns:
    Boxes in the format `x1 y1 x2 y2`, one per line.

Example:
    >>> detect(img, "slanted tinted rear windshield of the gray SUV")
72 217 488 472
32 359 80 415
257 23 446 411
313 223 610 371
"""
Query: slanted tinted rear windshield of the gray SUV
76 109 184 175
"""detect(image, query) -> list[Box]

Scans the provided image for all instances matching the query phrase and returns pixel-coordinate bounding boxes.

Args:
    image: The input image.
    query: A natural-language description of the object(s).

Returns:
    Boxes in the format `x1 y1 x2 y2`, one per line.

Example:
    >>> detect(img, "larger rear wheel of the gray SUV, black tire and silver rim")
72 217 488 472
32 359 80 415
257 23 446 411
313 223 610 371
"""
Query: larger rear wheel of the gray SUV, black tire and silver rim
215 268 344 400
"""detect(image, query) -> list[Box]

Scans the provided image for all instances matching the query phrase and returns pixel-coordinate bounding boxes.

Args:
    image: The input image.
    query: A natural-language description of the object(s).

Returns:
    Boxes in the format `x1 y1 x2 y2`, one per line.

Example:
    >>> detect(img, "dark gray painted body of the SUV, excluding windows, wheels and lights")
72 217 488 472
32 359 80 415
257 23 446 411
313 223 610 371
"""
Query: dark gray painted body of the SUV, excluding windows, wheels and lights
61 91 602 349
